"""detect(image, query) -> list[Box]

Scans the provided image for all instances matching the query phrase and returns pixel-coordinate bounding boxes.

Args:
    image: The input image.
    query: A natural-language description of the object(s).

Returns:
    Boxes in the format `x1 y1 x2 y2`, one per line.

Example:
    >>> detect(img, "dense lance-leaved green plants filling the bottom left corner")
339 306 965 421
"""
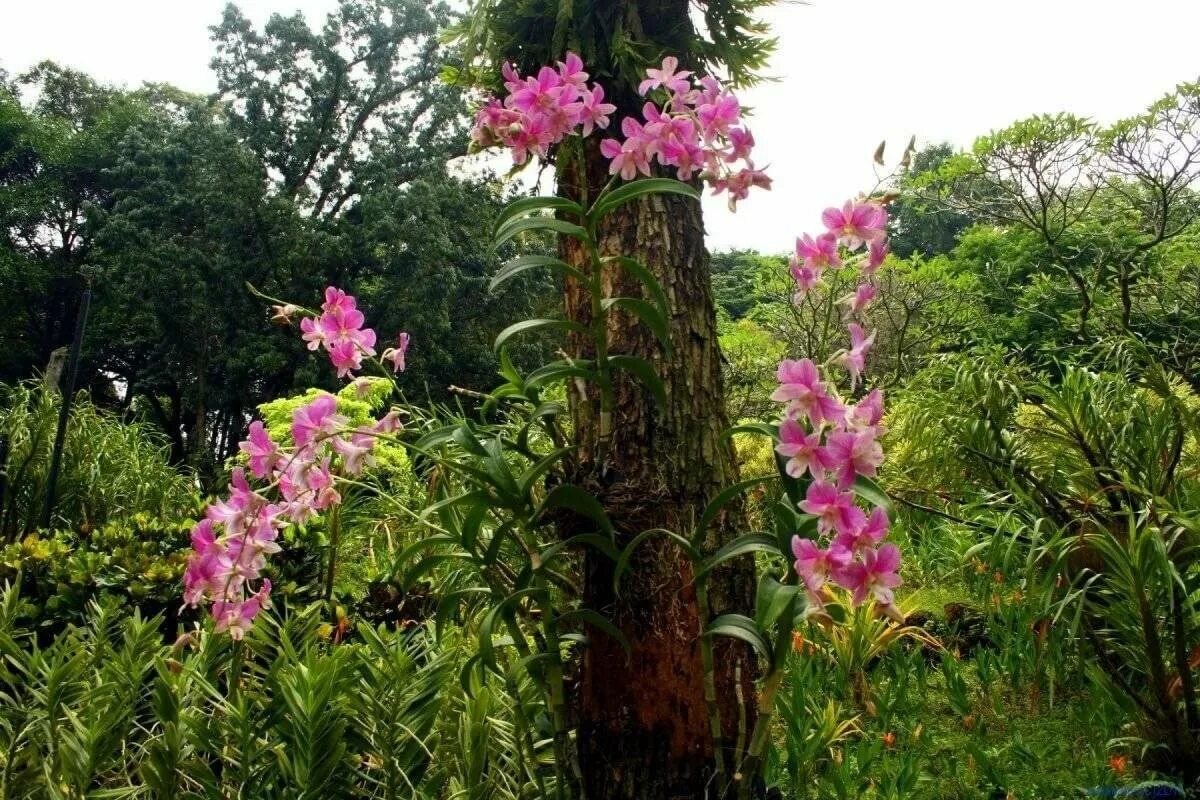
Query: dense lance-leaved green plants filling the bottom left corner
0 589 454 798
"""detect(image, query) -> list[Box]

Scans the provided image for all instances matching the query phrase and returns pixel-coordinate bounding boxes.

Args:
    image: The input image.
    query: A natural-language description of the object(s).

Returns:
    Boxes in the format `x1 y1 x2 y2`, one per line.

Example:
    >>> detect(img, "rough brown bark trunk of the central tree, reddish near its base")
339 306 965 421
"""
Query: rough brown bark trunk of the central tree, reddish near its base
558 139 754 800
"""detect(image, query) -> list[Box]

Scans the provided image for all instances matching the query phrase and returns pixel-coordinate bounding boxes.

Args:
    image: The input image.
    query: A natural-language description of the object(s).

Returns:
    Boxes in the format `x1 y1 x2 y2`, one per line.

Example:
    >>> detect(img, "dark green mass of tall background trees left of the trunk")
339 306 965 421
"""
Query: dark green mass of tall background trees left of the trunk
0 0 553 472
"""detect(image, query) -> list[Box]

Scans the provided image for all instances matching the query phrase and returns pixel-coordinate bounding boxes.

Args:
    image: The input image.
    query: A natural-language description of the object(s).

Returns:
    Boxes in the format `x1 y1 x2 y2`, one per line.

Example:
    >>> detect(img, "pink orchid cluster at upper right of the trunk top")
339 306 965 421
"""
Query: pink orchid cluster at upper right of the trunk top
600 56 770 209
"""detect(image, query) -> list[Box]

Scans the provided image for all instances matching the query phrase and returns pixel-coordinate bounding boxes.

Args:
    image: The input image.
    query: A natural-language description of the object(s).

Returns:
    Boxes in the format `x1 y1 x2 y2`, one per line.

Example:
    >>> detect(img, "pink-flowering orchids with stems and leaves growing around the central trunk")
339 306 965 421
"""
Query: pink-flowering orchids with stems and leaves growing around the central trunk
185 53 900 796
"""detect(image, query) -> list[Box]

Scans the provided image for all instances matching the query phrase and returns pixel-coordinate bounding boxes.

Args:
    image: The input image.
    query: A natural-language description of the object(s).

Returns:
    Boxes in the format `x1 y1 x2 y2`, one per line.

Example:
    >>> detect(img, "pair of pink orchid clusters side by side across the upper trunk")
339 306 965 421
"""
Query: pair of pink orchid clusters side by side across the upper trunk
472 53 770 207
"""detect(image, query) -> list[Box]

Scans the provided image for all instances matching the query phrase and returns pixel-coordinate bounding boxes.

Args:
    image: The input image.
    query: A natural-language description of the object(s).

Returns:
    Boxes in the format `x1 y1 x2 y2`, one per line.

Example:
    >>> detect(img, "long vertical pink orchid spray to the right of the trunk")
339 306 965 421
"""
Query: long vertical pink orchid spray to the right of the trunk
772 196 901 615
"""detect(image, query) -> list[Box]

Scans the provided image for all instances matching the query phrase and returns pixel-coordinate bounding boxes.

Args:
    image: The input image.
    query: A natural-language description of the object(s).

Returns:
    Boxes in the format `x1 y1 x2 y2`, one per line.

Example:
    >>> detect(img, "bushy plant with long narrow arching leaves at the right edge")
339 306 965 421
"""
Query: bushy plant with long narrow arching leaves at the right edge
893 357 1200 781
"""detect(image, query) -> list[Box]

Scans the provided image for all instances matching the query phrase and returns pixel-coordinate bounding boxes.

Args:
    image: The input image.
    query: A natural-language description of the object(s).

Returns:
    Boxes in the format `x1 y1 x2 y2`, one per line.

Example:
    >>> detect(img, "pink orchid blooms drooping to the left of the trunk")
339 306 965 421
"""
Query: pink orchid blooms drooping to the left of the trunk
184 287 408 639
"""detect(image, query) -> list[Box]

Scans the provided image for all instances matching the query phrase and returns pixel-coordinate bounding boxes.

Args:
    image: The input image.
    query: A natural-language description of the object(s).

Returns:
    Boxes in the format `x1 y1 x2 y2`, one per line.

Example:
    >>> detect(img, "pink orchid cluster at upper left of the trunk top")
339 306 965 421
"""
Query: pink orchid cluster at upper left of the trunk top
470 53 617 164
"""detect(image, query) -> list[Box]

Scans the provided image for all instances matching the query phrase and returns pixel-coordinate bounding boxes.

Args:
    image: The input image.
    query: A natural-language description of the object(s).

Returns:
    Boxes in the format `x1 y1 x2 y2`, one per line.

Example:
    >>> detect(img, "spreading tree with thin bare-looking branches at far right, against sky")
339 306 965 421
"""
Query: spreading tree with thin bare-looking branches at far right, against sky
916 83 1200 385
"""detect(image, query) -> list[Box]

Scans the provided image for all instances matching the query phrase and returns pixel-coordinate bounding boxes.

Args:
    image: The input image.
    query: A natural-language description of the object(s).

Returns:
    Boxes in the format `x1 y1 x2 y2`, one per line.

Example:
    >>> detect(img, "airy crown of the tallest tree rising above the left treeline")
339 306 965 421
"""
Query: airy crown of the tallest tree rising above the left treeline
212 0 466 217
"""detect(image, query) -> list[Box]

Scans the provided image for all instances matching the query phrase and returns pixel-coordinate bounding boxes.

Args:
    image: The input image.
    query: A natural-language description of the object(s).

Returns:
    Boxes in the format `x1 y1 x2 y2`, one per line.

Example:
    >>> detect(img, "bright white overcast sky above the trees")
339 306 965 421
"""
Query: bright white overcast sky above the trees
0 0 1200 251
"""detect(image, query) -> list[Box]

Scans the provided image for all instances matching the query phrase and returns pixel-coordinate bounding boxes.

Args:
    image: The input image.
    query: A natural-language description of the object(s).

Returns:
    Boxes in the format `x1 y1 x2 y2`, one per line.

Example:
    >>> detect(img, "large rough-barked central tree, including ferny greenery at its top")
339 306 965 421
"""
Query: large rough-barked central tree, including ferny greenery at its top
453 0 773 800
